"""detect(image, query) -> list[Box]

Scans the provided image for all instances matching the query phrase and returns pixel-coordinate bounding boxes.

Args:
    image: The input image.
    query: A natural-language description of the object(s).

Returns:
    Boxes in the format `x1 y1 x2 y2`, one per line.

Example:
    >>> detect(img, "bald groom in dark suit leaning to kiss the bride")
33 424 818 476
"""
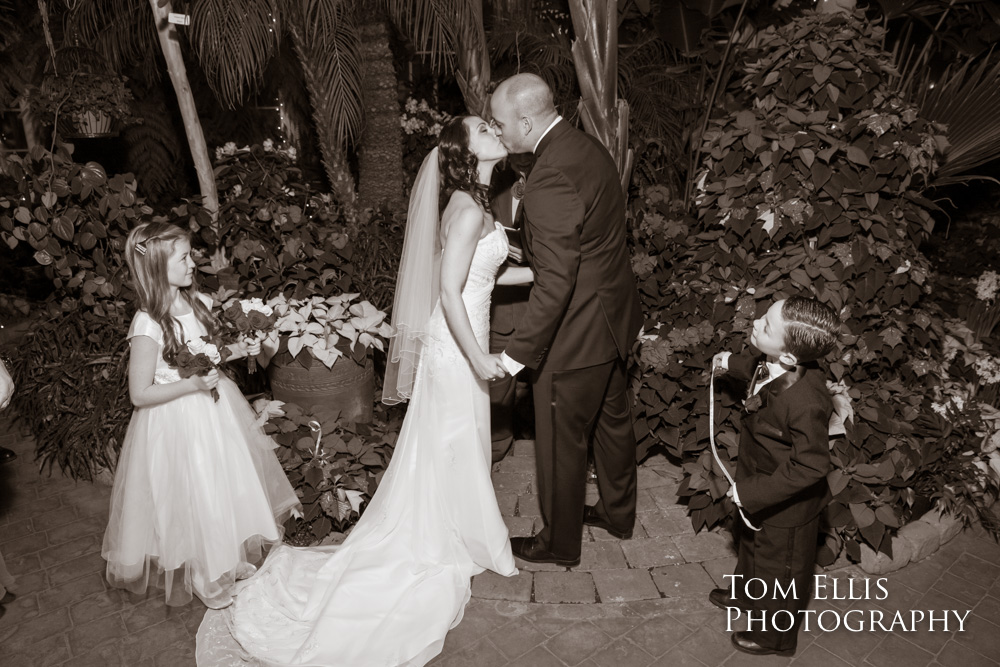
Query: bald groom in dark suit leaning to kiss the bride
490 74 642 567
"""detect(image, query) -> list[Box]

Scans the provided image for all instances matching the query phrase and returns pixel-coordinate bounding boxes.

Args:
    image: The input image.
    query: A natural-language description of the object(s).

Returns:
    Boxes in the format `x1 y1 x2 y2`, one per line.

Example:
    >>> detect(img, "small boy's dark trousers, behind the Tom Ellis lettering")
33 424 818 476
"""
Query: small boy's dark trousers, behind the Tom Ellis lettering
734 513 820 651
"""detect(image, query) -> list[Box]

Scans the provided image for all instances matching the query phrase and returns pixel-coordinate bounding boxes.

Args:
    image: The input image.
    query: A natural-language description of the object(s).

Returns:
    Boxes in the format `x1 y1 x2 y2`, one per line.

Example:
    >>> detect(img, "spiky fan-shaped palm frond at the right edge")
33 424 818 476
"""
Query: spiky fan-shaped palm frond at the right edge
917 58 1000 185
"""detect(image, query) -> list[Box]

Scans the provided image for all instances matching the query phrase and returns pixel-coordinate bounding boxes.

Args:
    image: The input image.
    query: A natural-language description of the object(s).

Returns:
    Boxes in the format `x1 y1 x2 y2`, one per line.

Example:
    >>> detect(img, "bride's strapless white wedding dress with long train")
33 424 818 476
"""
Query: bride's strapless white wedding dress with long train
197 224 517 667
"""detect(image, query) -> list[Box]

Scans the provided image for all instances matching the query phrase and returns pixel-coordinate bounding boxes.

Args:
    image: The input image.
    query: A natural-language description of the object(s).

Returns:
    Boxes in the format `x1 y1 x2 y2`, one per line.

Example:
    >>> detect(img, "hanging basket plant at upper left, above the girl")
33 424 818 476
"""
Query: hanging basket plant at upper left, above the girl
28 68 134 137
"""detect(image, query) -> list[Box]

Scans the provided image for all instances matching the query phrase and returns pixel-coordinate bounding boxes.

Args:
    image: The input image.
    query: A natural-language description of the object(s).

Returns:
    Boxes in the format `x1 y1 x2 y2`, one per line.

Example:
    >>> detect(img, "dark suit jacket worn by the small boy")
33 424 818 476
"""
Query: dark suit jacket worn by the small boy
729 354 833 528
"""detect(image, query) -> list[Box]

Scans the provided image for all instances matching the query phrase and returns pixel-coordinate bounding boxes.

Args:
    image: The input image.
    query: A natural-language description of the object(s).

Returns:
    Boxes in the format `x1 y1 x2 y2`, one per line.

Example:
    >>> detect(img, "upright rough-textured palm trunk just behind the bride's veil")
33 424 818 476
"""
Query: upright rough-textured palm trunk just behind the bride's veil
358 20 403 210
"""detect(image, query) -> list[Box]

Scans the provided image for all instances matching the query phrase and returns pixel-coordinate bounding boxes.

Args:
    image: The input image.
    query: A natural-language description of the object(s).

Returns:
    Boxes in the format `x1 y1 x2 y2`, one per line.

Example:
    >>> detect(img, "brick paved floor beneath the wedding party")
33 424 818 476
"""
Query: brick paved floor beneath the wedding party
0 422 1000 667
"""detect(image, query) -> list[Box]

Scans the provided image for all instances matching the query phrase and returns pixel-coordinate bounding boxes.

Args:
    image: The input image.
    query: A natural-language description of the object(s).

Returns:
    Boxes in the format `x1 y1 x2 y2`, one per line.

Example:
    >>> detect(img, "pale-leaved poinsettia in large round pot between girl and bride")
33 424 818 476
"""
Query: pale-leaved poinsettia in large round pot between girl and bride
265 293 392 422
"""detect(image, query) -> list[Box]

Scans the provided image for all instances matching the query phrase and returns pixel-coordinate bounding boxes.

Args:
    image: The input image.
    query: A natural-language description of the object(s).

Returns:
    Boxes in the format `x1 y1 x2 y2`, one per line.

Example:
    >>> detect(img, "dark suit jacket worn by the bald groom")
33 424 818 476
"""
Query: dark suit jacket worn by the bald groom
506 121 642 371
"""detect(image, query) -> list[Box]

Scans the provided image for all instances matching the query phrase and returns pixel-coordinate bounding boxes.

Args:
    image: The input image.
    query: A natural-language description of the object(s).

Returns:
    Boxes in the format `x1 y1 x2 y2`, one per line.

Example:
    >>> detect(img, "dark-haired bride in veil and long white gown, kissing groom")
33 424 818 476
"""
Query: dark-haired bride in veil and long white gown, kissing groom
197 116 531 667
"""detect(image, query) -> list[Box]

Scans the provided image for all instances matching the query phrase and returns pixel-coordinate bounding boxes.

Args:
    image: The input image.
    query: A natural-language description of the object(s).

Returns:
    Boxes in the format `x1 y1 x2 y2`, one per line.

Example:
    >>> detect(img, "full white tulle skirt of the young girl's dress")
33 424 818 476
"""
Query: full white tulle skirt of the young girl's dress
102 377 299 606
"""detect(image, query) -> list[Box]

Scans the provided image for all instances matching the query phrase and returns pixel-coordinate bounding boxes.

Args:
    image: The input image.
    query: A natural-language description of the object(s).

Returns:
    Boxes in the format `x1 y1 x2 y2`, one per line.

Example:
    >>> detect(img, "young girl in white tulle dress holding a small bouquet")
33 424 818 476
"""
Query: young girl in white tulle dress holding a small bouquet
102 222 300 608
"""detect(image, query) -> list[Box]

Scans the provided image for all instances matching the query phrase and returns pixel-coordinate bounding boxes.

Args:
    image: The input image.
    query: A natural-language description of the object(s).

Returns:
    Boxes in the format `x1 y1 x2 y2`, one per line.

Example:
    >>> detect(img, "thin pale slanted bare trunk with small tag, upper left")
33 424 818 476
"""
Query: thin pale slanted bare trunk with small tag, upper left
149 0 219 221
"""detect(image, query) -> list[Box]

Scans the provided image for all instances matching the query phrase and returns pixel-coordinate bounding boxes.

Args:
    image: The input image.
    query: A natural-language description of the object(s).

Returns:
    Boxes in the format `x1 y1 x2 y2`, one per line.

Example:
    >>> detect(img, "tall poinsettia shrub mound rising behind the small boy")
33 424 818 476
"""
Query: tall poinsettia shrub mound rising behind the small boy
633 12 988 562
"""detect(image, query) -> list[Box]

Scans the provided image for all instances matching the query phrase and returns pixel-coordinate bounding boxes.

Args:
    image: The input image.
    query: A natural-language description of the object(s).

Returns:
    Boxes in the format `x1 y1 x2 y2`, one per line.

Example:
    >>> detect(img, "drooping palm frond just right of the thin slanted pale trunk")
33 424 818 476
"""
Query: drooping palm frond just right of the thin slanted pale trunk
189 0 282 107
